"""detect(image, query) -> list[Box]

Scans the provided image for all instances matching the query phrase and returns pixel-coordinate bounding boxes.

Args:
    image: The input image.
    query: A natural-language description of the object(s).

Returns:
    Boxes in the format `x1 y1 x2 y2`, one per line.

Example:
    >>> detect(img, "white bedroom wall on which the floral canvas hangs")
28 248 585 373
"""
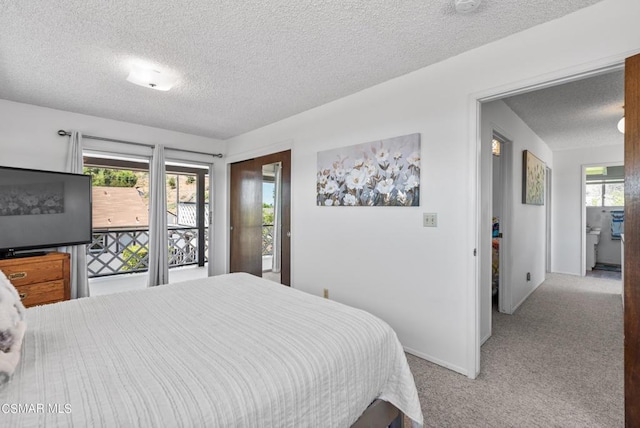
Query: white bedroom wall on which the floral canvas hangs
216 0 640 376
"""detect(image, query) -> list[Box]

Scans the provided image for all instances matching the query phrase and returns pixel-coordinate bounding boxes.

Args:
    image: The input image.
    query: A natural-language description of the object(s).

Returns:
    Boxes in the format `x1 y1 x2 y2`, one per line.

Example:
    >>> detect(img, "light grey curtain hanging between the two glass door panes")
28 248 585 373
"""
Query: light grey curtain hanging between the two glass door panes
147 145 169 287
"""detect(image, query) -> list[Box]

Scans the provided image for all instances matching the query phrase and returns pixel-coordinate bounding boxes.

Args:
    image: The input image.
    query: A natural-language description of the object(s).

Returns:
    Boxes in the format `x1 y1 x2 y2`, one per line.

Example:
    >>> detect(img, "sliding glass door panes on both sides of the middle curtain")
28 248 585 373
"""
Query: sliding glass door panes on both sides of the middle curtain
84 156 208 278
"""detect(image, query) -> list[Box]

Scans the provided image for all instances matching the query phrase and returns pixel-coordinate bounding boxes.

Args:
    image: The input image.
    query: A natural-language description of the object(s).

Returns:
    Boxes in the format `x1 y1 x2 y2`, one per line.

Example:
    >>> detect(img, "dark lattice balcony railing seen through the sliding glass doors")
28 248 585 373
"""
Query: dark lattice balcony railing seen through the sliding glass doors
87 227 209 278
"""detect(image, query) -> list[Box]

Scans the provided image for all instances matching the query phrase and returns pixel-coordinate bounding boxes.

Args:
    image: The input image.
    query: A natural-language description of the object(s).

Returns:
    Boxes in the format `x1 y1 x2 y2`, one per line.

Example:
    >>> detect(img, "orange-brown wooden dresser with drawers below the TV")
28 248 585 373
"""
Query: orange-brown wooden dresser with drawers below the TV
0 253 70 307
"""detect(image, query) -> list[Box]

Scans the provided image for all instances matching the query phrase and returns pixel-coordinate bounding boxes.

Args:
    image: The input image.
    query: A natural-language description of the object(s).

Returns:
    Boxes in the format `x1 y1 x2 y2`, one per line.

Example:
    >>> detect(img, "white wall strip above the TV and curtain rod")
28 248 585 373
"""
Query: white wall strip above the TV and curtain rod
0 100 225 171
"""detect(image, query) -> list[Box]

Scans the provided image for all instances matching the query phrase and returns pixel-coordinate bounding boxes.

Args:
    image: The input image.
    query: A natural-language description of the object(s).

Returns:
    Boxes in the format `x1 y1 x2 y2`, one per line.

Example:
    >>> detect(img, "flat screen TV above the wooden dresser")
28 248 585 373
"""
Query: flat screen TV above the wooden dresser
0 166 91 257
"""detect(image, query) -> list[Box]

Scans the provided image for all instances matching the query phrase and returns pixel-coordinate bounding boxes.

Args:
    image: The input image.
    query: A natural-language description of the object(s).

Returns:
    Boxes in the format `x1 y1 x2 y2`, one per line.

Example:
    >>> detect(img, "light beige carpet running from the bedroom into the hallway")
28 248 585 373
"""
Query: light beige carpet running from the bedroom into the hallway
407 274 624 428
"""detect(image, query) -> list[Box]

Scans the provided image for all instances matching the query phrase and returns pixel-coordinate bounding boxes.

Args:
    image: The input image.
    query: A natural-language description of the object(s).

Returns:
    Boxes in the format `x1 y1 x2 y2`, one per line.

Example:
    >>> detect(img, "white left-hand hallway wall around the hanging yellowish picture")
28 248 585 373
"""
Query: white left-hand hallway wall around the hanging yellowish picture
480 101 553 339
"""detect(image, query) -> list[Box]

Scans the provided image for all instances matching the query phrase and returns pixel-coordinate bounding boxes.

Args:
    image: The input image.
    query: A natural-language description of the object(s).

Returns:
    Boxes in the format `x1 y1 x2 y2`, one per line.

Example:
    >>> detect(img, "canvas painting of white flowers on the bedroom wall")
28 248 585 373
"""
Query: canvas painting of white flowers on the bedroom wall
316 134 420 207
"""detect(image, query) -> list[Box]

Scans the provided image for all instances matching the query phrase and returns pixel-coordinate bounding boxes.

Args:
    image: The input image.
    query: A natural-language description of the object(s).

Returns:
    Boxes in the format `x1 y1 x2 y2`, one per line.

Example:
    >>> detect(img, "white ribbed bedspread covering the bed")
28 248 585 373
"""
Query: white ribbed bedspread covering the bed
0 274 422 428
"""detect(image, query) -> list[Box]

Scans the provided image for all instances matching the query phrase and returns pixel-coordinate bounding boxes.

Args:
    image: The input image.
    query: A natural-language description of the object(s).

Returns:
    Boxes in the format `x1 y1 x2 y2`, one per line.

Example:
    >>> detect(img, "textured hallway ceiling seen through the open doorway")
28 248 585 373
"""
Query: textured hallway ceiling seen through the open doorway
503 71 624 150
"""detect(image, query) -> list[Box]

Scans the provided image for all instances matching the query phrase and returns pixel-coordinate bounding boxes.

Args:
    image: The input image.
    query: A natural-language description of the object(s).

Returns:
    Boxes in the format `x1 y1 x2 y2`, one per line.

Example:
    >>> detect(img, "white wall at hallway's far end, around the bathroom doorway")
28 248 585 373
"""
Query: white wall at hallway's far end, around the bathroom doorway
551 144 624 275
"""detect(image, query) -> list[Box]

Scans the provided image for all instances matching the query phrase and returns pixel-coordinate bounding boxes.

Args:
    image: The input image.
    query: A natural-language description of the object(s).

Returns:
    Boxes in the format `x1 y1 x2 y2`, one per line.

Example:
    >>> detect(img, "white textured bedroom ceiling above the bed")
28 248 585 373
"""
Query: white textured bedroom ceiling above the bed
0 0 600 139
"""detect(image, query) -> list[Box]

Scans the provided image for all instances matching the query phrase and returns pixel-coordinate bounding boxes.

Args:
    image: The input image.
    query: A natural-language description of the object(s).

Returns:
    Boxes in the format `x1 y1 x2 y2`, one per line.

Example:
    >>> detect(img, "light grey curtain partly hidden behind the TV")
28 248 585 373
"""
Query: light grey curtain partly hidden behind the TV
64 131 89 299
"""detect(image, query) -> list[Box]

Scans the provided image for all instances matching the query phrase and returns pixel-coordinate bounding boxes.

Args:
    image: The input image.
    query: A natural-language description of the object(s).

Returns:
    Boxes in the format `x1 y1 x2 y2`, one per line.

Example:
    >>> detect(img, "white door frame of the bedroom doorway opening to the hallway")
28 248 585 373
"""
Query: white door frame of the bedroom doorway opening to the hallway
466 57 637 379
